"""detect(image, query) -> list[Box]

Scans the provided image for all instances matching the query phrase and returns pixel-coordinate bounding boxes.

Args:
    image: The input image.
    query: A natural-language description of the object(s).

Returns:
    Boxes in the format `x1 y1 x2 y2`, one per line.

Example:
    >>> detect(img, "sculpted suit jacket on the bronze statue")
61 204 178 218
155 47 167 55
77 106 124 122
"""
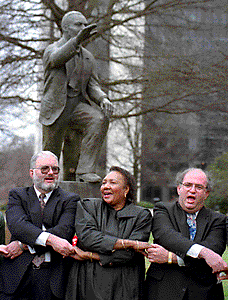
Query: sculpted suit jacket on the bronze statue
39 37 106 126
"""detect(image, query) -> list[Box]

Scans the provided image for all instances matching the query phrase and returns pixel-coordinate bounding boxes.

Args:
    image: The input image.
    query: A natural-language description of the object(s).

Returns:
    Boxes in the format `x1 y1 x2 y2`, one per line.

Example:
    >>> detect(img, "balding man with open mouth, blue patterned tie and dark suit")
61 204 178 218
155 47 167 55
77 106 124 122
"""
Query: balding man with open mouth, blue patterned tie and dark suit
145 168 227 300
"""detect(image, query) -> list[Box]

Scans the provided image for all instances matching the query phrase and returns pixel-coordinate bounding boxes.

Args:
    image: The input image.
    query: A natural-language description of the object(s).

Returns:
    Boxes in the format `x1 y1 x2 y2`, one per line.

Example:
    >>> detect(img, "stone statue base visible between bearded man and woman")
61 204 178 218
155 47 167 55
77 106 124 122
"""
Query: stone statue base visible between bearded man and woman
59 181 101 199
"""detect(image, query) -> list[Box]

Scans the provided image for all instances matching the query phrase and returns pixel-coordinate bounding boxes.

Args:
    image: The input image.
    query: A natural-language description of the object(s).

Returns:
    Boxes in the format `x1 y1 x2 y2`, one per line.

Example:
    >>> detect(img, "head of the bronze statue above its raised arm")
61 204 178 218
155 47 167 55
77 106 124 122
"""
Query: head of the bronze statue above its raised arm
61 11 87 38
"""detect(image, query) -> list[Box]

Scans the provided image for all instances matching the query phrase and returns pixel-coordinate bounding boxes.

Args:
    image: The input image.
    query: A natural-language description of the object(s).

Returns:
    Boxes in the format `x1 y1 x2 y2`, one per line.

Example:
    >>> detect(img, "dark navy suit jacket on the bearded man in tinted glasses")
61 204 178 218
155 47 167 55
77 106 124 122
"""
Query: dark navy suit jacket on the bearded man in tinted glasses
0 187 79 298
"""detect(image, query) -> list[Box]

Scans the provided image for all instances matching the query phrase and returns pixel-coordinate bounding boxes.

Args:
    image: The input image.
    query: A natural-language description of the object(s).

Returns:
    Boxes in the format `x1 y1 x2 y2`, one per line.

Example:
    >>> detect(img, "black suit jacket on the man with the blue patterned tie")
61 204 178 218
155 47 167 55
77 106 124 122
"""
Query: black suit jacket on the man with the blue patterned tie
147 202 226 300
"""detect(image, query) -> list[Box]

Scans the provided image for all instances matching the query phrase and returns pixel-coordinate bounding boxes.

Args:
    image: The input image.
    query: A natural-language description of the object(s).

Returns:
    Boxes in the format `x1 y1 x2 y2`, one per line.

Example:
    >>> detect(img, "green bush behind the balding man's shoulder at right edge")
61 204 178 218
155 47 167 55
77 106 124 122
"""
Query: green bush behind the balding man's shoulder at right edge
206 153 228 214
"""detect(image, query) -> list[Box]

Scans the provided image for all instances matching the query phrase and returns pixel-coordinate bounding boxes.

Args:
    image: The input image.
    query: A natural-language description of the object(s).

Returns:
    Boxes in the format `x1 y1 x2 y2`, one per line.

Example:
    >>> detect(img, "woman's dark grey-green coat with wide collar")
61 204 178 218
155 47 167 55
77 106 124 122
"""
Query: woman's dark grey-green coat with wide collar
66 199 152 300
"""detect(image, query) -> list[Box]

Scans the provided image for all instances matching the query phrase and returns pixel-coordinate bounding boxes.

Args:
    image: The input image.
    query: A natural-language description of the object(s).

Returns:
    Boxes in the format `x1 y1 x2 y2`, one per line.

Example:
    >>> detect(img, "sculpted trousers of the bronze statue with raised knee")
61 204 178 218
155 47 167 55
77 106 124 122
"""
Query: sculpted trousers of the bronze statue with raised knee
43 97 109 181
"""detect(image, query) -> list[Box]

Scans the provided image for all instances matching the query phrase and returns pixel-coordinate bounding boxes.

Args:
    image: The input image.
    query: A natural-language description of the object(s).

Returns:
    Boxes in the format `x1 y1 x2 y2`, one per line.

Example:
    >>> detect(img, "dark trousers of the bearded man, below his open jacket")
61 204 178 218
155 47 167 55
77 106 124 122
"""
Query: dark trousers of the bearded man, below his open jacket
0 265 63 300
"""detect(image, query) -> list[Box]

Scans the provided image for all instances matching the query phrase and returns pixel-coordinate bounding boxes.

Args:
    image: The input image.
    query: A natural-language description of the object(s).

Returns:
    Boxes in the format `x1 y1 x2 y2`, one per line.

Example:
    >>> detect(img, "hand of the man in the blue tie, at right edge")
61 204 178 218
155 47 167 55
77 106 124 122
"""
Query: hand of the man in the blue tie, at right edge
199 247 228 273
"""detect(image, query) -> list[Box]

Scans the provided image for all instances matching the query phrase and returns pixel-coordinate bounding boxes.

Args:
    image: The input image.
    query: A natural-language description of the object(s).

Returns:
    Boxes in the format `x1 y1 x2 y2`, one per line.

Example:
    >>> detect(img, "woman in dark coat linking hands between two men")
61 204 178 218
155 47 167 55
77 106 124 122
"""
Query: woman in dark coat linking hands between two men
66 167 152 300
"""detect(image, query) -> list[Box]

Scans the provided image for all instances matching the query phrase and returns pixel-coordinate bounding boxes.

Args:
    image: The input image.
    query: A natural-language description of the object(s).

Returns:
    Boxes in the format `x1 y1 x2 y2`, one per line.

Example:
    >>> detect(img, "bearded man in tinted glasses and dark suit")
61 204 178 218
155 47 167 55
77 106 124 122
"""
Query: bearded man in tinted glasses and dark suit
0 151 79 300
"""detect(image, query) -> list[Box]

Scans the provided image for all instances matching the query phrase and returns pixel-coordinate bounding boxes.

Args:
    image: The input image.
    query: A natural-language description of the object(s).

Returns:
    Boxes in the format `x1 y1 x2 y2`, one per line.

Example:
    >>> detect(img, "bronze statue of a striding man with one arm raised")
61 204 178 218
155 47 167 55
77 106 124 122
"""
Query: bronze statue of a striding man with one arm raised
39 11 113 182
